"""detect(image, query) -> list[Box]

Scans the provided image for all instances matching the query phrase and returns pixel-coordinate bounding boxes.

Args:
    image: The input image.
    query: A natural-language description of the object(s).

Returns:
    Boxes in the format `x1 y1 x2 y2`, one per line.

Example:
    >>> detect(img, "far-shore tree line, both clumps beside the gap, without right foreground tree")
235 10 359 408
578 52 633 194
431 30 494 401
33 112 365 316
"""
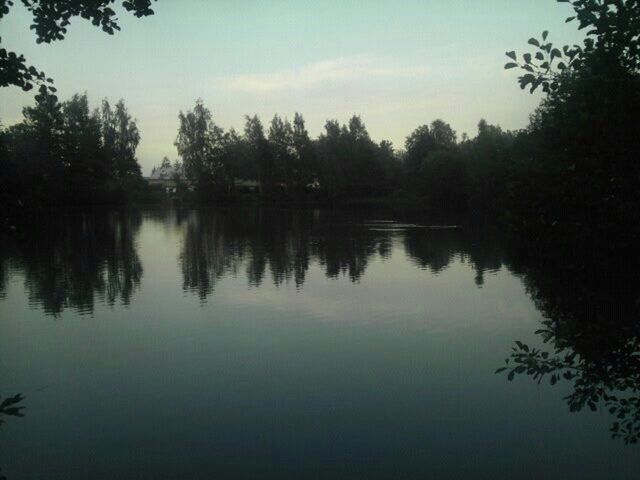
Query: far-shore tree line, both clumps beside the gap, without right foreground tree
0 92 516 210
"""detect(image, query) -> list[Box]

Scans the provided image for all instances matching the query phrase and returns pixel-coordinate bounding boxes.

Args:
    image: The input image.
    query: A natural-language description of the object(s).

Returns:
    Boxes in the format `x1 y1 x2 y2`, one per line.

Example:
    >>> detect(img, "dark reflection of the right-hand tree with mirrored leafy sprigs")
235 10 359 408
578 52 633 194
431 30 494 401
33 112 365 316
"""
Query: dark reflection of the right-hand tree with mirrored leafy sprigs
499 249 640 443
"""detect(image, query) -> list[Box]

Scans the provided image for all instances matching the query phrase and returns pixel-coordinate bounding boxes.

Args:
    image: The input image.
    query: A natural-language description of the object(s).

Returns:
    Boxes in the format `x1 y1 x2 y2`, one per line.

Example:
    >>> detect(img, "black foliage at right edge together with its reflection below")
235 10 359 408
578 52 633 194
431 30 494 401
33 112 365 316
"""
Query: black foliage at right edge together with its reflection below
498 0 640 443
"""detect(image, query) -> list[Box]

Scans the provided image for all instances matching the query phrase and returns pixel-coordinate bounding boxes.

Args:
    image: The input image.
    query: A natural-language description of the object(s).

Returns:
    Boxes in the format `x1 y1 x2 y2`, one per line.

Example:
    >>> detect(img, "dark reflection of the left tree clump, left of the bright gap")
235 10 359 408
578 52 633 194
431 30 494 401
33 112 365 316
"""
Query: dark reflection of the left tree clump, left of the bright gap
0 212 142 316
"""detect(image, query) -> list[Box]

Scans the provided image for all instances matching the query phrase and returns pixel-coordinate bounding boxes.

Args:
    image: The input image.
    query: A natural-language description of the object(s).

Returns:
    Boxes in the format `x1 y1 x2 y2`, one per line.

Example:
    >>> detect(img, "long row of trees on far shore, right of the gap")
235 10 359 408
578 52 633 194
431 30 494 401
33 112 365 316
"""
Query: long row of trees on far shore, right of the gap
161 100 525 212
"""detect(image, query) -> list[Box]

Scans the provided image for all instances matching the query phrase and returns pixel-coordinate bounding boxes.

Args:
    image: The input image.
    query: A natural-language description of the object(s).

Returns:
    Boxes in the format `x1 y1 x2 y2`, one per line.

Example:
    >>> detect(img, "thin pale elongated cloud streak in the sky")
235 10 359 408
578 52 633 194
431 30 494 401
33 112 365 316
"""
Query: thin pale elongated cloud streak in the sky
218 56 426 94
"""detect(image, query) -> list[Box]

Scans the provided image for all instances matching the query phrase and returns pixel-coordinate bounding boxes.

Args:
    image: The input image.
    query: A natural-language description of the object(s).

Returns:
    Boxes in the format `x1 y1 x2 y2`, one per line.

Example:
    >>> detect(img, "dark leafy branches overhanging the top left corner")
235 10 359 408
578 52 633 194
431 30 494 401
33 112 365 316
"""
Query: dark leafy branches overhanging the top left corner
0 0 155 93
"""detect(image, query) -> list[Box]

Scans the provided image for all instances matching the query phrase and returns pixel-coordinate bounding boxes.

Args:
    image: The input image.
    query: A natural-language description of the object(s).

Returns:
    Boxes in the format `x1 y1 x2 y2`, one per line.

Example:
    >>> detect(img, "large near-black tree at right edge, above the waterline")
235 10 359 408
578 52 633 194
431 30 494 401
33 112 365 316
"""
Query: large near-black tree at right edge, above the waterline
505 0 640 240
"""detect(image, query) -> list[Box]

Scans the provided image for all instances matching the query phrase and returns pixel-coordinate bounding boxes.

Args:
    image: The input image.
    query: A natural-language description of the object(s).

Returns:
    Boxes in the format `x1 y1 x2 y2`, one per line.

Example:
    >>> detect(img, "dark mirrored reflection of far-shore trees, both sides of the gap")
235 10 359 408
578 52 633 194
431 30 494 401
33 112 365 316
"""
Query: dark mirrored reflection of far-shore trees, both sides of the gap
0 208 516 315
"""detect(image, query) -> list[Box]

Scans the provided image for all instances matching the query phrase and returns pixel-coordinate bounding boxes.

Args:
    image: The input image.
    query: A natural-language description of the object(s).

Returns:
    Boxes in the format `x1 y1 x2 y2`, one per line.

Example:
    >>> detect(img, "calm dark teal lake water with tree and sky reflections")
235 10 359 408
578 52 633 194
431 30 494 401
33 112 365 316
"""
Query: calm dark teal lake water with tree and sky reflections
0 209 640 480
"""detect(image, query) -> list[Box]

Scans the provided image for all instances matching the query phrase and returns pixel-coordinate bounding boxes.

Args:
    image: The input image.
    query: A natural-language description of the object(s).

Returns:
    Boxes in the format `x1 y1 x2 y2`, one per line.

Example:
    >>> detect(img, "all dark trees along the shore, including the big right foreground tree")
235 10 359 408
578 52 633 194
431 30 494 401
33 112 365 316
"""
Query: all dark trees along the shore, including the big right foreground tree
0 0 640 248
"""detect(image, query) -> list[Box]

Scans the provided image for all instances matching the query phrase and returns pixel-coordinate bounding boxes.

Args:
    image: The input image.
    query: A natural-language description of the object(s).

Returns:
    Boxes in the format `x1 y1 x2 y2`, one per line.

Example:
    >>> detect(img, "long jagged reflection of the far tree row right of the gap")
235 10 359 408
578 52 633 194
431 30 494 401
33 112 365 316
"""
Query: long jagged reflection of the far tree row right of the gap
171 209 504 299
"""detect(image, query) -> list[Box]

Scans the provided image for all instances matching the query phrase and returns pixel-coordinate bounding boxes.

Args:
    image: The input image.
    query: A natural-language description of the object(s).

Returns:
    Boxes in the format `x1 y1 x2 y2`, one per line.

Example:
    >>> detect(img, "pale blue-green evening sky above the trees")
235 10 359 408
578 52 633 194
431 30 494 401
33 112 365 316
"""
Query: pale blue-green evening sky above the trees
0 0 582 174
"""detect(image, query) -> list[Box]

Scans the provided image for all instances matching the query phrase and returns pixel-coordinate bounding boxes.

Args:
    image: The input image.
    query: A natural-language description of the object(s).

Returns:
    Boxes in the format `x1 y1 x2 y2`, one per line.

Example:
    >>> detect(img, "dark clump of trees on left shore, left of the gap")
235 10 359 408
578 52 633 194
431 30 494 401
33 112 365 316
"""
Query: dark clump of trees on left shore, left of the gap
0 93 143 231
